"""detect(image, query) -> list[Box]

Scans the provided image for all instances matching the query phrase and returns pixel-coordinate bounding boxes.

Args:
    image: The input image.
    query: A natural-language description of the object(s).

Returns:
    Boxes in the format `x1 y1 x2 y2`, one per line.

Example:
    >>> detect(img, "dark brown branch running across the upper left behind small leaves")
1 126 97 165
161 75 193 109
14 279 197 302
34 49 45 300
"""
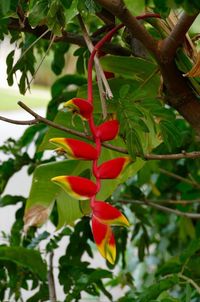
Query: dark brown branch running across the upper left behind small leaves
8 18 131 56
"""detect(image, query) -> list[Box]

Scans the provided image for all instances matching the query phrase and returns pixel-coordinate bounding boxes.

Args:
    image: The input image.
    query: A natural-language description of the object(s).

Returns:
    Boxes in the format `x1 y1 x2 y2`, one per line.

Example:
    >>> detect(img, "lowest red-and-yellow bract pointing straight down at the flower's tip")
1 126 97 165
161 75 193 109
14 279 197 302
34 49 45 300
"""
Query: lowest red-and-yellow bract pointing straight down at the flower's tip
92 216 116 264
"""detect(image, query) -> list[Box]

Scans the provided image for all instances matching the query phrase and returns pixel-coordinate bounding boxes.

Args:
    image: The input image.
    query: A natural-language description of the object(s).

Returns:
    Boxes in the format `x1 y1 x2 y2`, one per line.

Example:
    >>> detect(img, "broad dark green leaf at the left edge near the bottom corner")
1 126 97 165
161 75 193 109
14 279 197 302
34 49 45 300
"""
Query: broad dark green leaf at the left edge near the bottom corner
0 246 47 281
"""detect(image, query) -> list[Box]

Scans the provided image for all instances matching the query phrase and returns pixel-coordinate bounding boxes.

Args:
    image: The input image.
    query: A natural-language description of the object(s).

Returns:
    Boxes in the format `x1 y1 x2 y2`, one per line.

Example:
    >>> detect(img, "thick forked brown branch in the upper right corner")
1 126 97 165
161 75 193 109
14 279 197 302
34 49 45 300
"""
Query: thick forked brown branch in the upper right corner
96 0 200 134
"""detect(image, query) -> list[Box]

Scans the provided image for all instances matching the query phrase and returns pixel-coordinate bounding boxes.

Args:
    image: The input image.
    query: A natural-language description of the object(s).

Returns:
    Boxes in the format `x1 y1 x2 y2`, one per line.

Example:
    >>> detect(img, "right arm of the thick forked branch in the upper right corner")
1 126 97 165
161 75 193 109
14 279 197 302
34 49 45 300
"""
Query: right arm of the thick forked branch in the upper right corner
161 12 198 63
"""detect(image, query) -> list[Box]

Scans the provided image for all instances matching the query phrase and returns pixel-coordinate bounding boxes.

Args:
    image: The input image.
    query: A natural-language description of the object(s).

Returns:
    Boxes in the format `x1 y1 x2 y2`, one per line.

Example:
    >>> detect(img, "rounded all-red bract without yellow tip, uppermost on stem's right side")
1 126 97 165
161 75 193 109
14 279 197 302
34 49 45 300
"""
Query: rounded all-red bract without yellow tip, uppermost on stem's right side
96 120 119 142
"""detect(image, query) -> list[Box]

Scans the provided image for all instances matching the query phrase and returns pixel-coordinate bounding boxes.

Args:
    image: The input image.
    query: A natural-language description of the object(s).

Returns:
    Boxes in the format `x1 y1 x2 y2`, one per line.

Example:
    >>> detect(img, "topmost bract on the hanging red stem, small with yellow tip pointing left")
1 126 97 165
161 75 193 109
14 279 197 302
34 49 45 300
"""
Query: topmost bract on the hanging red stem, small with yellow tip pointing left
64 98 93 120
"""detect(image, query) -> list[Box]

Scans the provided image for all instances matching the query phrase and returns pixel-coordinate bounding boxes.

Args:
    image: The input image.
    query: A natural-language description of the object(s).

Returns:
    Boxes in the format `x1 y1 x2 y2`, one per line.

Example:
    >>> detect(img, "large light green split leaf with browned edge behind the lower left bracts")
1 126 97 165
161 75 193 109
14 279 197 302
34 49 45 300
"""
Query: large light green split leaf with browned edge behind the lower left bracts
25 160 90 227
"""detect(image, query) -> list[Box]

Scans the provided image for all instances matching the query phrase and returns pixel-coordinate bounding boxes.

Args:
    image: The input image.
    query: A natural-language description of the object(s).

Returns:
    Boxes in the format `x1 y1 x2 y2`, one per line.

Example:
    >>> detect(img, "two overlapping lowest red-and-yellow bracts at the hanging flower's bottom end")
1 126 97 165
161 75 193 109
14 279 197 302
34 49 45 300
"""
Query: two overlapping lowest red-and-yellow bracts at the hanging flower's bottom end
92 201 129 264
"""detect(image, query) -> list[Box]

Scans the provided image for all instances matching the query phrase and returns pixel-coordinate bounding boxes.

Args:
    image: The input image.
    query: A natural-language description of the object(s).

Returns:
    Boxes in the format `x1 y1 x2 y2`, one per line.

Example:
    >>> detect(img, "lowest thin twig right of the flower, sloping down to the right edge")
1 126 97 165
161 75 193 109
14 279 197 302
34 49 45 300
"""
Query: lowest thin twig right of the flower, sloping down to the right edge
119 199 200 219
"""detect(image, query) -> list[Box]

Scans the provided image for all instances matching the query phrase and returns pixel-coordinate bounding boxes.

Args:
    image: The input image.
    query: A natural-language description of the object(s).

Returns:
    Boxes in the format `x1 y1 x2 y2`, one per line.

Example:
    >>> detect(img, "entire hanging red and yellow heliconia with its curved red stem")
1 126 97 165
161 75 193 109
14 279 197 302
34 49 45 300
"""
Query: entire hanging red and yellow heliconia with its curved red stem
50 25 130 264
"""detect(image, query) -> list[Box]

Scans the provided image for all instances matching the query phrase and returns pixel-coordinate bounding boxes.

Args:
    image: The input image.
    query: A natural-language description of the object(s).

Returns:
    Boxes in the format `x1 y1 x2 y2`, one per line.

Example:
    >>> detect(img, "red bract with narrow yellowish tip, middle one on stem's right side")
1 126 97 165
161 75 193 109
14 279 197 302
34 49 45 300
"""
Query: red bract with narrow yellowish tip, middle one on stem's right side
98 156 131 179
